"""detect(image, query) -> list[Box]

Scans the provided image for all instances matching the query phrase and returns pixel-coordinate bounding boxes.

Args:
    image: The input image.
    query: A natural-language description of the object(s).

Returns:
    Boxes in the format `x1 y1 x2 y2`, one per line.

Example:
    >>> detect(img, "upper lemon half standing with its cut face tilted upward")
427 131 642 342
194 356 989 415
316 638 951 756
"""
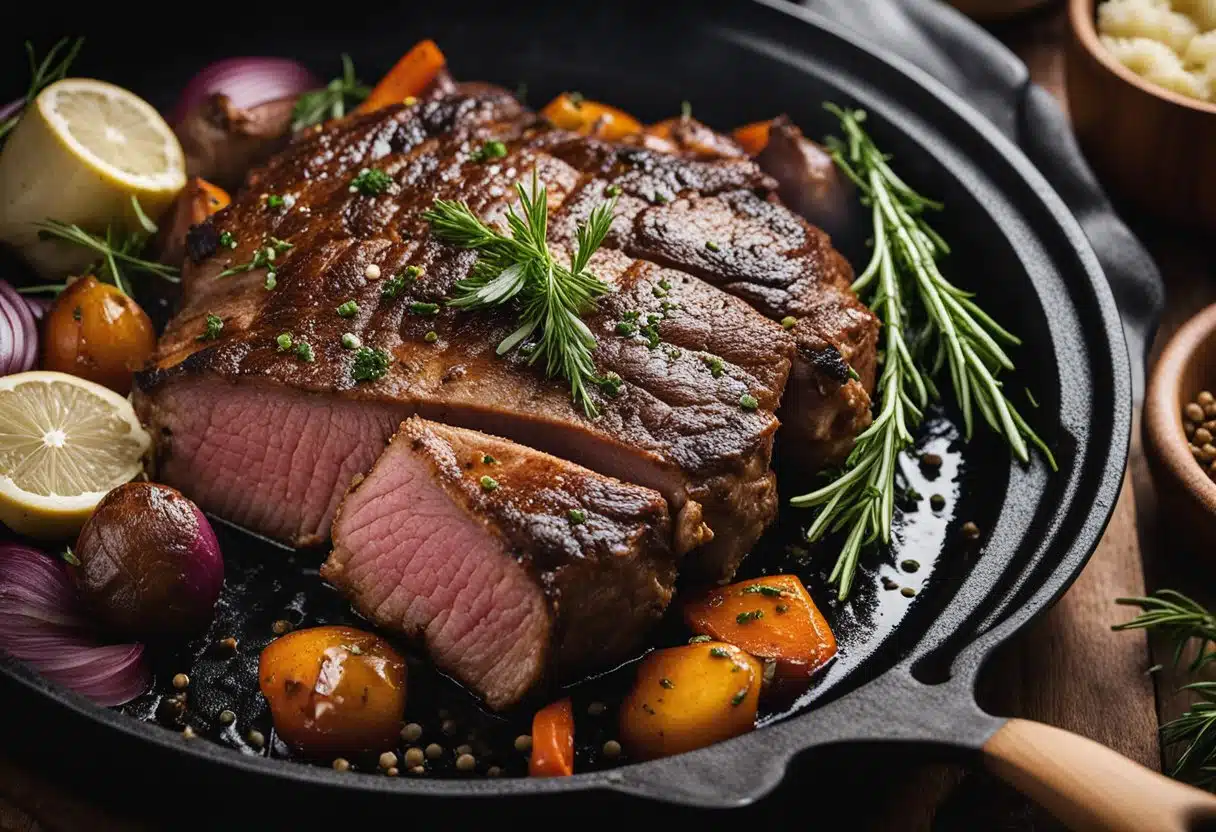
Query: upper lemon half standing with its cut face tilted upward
0 78 186 277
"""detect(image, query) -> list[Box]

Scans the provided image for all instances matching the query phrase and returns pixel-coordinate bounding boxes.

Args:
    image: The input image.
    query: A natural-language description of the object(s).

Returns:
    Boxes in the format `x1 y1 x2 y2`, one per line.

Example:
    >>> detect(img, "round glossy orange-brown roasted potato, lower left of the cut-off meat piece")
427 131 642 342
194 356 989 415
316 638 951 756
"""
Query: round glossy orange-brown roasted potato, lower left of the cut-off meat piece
258 626 406 759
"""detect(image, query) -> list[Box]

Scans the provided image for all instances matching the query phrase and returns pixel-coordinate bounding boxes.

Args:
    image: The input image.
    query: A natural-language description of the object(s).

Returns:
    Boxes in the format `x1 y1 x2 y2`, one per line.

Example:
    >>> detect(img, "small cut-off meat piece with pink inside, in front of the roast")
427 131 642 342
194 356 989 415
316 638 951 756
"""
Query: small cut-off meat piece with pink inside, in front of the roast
321 417 676 708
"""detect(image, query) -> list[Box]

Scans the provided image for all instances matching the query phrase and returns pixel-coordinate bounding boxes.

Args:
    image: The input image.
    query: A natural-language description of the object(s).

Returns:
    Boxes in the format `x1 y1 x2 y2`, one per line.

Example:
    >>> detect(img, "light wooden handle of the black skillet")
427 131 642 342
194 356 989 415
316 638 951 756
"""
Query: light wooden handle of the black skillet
984 719 1216 832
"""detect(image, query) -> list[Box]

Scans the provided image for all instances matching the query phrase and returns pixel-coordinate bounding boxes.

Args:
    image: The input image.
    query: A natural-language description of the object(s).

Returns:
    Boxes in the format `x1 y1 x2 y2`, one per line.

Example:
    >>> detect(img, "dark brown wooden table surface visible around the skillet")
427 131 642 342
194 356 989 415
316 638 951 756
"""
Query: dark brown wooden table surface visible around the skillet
0 6 1216 832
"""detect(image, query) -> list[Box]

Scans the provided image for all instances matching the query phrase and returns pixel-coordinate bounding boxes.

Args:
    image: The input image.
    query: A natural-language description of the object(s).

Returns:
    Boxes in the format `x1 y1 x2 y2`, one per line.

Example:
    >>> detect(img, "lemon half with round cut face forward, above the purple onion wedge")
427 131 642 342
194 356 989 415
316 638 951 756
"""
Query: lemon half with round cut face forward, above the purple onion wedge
0 372 152 540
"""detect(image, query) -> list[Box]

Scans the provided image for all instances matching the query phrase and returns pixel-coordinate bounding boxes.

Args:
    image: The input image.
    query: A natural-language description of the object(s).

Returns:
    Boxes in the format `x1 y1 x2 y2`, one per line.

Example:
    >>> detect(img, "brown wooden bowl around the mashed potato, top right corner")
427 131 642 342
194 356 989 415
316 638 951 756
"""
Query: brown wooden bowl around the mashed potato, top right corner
1065 0 1216 229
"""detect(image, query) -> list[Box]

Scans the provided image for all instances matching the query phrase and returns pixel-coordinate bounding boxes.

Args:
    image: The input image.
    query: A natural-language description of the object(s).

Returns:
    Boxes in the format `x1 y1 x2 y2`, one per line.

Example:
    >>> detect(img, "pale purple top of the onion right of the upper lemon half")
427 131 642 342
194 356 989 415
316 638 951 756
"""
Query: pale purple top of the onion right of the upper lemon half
169 57 322 124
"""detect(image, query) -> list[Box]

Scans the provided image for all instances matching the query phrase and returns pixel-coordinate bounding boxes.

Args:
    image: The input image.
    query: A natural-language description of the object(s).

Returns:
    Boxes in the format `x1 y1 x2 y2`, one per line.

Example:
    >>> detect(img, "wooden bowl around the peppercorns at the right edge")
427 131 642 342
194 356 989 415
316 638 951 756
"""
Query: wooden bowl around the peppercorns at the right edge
1143 304 1216 546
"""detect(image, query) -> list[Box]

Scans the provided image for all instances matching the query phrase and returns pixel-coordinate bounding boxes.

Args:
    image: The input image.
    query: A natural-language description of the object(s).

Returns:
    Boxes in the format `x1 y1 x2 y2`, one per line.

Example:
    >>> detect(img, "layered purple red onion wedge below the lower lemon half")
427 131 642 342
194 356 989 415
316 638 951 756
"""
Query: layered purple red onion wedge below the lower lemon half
0 543 152 707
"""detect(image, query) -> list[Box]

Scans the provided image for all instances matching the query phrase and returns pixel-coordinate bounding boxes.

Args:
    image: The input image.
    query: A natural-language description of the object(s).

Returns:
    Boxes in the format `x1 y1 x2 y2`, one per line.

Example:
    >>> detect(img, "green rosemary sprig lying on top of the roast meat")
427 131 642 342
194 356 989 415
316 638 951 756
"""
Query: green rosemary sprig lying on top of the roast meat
423 172 617 417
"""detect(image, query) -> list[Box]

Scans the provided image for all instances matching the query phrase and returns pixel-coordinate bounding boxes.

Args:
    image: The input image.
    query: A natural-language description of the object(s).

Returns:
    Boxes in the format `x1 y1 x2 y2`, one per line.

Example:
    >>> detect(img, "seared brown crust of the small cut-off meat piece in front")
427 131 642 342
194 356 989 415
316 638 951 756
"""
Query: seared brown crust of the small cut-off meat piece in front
321 417 677 707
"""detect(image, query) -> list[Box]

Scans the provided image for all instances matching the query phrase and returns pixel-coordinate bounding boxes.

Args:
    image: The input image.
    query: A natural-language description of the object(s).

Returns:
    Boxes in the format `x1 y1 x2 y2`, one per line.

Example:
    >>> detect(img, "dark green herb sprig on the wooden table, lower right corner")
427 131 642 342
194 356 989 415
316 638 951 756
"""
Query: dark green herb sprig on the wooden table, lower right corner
1110 589 1216 786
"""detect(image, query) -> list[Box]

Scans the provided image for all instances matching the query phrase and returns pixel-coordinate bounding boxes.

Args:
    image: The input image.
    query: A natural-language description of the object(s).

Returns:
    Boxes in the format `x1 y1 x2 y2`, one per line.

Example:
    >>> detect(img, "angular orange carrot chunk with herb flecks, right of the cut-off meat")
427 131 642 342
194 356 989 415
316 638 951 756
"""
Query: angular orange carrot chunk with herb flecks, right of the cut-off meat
683 575 837 686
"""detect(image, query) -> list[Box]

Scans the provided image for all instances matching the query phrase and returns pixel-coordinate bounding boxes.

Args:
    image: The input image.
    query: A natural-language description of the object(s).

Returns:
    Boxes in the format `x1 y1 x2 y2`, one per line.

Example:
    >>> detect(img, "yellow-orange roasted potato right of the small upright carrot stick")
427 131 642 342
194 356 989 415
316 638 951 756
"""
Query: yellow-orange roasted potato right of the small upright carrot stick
620 641 764 760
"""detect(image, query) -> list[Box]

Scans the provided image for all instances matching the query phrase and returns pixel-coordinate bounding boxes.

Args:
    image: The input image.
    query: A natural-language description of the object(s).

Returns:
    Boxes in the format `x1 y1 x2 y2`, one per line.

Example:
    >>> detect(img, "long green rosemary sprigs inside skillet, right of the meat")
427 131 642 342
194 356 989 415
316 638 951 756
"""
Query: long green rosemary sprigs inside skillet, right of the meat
790 103 1055 601
